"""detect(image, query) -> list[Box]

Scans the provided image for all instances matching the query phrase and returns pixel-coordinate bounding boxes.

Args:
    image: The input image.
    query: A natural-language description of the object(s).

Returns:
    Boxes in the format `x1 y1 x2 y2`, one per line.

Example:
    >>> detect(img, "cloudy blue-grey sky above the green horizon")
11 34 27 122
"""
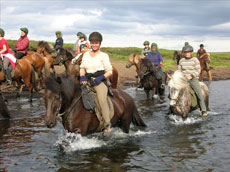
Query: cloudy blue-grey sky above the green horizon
0 0 230 52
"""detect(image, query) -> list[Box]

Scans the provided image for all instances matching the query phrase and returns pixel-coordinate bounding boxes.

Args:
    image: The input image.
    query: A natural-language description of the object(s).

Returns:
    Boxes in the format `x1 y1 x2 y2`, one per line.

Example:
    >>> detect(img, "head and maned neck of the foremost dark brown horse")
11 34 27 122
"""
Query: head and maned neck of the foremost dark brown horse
43 74 81 128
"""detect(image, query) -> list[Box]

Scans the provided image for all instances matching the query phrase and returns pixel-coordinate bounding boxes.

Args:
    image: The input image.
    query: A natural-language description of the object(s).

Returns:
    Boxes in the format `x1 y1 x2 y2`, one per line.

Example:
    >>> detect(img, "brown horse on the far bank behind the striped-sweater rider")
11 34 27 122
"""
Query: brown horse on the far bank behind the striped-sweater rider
198 53 212 84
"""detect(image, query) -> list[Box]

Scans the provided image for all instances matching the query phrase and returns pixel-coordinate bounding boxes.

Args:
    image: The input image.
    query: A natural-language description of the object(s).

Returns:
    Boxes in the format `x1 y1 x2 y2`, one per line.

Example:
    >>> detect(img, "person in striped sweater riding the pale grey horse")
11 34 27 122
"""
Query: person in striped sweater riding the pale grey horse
178 45 208 117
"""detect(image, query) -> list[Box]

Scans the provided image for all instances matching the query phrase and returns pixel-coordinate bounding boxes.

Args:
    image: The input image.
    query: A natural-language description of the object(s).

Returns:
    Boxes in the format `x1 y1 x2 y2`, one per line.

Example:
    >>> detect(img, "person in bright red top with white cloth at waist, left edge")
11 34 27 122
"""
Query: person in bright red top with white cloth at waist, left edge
0 28 16 84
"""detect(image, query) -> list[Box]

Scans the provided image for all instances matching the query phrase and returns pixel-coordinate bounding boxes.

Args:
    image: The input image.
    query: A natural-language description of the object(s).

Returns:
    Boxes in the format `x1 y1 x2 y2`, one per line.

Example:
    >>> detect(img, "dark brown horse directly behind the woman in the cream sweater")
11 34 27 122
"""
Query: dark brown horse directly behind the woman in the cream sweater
55 48 118 88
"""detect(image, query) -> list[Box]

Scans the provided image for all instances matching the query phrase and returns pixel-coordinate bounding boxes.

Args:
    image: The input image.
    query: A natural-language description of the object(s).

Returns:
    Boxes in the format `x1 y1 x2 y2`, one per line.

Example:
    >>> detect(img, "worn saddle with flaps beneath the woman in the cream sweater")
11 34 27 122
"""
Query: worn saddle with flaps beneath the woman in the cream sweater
81 85 114 131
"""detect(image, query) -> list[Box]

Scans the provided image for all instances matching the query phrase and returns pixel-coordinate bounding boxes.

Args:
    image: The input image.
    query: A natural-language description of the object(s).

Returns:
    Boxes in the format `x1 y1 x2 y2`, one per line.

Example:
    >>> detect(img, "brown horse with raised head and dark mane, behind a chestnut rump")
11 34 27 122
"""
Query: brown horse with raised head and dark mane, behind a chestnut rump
37 41 56 75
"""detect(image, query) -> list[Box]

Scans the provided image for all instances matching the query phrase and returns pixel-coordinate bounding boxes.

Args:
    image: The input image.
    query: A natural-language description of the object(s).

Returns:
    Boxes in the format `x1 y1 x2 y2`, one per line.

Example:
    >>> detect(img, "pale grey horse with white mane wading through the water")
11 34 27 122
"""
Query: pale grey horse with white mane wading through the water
168 70 209 118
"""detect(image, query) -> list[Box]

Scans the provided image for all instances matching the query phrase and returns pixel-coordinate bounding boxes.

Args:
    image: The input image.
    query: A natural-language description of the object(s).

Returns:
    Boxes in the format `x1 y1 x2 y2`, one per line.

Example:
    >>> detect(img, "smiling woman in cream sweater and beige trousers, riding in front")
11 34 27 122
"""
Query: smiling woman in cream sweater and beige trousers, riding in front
80 32 112 136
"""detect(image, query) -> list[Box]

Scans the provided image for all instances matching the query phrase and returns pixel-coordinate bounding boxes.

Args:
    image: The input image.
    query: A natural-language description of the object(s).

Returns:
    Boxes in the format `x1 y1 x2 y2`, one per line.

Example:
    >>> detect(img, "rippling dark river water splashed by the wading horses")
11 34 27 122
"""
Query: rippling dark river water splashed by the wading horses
0 81 230 172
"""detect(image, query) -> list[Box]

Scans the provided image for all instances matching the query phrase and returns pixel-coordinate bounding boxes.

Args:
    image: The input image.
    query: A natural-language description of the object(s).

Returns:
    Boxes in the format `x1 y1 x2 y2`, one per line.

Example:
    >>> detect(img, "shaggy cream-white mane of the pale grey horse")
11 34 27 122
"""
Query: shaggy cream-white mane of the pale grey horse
168 70 189 89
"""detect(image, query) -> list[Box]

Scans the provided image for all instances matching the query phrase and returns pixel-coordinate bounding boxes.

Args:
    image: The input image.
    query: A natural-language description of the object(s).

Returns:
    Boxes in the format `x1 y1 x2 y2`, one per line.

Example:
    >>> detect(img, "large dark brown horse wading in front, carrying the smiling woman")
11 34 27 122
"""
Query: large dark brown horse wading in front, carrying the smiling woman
44 75 146 136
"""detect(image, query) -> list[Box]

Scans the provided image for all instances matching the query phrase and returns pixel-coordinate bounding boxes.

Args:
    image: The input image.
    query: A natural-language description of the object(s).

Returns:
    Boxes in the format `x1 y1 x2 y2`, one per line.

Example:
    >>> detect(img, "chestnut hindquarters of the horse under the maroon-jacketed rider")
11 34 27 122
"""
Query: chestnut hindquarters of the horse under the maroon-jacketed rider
23 52 46 88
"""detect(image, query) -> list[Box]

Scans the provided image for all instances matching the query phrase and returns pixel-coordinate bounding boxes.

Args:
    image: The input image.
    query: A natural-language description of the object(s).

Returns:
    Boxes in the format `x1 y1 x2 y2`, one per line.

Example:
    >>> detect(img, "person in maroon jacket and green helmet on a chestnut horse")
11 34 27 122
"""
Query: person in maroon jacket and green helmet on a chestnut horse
13 27 30 59
